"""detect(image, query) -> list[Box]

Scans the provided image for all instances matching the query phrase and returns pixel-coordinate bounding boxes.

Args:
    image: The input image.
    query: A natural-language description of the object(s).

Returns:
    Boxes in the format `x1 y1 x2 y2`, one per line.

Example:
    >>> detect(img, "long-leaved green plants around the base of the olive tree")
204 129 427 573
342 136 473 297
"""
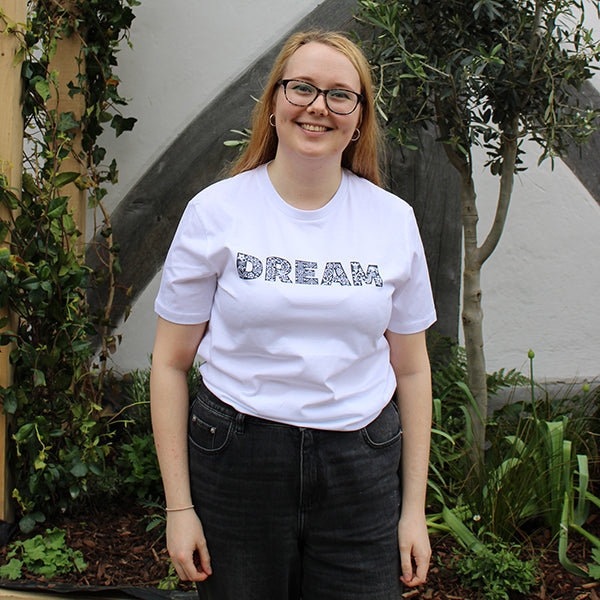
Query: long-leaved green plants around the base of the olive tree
428 352 596 556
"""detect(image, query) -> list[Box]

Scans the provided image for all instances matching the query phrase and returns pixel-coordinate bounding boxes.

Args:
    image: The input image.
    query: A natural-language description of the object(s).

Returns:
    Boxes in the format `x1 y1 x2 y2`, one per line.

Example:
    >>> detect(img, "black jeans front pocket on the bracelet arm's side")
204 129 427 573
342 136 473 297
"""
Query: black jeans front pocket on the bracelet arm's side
188 397 234 453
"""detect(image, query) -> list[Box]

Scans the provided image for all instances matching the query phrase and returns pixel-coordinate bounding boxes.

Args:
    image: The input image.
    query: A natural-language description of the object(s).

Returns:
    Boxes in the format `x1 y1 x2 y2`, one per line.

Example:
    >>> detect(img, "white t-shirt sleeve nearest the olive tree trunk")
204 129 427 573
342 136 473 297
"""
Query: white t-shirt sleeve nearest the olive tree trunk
388 210 436 334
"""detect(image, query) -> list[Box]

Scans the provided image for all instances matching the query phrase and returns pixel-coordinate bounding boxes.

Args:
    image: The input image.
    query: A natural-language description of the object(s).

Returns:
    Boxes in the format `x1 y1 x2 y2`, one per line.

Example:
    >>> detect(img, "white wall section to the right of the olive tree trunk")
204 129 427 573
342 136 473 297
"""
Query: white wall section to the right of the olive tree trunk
468 144 600 381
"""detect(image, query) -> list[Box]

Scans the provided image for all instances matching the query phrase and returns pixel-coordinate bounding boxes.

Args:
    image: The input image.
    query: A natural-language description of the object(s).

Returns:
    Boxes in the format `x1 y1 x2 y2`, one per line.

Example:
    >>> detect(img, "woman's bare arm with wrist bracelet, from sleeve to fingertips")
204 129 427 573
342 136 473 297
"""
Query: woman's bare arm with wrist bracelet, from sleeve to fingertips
150 317 212 581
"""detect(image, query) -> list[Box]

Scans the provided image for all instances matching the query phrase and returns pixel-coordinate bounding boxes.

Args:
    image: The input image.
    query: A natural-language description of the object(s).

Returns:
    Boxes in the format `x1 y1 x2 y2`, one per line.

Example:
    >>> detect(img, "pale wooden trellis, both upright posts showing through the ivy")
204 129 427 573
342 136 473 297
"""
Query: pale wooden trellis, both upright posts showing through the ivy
0 0 86 521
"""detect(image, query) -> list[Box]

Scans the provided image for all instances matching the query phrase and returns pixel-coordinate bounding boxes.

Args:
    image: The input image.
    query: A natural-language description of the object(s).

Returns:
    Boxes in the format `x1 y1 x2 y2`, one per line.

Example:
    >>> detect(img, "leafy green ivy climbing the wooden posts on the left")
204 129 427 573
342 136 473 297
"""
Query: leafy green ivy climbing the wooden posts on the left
0 0 137 529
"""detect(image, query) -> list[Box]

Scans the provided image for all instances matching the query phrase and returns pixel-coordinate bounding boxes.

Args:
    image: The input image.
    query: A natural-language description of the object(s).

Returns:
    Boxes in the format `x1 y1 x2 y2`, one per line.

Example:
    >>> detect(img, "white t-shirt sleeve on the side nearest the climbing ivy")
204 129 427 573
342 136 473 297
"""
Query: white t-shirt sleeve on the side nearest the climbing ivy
154 203 217 325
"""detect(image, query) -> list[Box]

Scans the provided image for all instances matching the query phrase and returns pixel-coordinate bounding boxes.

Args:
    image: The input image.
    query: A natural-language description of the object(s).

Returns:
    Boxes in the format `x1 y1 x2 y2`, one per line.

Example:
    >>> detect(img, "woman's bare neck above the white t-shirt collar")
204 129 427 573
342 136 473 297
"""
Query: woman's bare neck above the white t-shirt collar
268 153 342 210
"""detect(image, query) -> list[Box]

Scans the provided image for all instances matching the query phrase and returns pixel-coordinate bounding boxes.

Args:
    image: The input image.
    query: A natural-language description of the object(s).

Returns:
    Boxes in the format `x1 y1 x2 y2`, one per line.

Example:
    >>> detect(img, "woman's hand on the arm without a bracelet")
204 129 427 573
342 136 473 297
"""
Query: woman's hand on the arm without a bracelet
398 514 431 587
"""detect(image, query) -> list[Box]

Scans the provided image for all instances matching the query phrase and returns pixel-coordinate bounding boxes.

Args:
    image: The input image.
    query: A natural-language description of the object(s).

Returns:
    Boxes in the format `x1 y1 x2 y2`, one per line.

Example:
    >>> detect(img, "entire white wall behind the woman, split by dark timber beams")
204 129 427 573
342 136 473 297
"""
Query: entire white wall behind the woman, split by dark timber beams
104 0 600 381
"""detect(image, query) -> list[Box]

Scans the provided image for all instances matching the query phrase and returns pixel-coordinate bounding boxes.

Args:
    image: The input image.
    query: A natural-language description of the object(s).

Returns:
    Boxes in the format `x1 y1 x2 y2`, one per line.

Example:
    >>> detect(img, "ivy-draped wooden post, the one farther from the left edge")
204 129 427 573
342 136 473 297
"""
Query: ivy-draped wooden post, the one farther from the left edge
48 0 87 244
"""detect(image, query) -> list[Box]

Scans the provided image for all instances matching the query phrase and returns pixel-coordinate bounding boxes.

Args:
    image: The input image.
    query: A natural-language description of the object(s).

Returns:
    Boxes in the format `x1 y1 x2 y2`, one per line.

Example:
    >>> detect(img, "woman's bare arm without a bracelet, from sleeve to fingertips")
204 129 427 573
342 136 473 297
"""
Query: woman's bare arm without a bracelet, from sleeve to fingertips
385 331 431 587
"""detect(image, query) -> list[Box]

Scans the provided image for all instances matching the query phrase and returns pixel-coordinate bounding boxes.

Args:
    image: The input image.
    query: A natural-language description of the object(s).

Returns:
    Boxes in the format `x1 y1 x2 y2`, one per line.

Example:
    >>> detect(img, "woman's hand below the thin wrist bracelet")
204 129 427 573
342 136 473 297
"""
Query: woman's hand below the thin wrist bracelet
167 509 212 581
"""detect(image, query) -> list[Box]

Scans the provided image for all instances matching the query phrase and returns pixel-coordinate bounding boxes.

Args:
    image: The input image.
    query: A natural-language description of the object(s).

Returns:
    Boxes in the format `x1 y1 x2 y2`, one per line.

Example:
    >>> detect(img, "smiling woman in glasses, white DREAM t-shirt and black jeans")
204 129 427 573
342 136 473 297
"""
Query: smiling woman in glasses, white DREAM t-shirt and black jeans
151 32 435 600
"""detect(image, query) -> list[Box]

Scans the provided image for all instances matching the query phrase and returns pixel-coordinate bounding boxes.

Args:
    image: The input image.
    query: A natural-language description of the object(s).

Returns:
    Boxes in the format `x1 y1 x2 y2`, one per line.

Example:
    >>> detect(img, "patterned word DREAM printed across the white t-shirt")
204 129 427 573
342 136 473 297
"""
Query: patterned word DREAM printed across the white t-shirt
237 252 383 287
